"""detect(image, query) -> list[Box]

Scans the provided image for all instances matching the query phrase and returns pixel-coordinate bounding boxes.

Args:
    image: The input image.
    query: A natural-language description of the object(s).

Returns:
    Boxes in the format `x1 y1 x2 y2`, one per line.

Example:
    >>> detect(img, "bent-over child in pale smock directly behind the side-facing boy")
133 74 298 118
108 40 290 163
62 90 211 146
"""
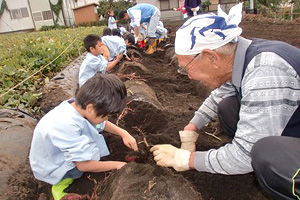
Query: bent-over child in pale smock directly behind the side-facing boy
102 34 134 61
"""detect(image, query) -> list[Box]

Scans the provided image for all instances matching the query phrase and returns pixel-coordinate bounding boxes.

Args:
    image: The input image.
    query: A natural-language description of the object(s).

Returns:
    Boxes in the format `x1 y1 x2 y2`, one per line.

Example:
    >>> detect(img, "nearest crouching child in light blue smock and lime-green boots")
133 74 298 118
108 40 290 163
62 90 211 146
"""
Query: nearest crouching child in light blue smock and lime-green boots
30 73 138 200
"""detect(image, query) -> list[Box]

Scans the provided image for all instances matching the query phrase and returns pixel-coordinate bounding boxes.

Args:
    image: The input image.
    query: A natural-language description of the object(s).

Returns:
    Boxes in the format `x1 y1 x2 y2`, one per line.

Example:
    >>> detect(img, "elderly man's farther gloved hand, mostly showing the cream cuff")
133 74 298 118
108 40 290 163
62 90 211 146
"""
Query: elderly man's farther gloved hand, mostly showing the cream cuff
179 131 199 152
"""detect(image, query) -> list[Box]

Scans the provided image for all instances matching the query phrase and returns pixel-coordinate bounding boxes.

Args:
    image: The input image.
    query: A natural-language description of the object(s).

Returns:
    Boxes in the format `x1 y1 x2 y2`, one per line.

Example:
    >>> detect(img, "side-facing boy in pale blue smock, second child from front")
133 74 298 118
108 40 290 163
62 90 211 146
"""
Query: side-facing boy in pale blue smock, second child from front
79 34 123 87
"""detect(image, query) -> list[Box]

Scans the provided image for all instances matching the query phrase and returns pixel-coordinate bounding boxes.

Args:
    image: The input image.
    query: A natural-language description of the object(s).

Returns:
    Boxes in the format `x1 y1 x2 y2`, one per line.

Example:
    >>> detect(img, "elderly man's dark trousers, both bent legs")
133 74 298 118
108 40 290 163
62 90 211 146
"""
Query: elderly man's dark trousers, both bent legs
218 97 300 199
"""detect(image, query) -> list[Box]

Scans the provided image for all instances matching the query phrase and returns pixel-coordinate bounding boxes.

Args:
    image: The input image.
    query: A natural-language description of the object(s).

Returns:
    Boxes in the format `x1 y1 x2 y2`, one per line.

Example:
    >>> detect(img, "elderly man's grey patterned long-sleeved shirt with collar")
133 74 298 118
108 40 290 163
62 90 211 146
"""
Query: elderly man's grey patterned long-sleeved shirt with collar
191 38 300 174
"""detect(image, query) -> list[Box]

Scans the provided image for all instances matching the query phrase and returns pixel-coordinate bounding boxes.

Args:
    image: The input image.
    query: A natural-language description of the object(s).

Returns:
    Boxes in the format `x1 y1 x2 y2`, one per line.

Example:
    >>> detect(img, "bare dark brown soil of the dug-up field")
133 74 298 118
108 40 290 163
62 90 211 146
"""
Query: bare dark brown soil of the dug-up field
7 16 300 200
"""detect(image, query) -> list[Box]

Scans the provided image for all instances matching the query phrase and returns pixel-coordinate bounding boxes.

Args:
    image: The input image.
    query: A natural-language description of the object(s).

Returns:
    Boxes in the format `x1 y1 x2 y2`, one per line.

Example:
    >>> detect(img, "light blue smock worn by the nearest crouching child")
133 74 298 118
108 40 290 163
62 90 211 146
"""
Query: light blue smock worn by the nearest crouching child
30 100 109 184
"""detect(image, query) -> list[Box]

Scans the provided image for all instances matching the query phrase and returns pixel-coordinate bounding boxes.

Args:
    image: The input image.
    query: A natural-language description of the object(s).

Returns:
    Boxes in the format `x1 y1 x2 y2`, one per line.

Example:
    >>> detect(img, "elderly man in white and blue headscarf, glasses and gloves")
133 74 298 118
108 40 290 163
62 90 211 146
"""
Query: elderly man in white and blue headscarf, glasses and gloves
151 4 300 199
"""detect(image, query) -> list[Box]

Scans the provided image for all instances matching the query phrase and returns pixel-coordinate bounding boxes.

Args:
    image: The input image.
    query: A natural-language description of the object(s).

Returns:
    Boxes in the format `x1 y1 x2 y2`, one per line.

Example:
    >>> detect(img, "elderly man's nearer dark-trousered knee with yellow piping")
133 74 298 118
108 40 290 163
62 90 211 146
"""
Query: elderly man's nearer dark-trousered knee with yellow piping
251 136 300 199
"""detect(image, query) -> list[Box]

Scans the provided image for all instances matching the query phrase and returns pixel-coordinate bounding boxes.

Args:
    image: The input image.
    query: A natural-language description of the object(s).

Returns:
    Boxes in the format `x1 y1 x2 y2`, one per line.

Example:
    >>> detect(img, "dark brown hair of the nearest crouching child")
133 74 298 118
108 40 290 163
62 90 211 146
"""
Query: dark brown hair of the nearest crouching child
75 73 127 117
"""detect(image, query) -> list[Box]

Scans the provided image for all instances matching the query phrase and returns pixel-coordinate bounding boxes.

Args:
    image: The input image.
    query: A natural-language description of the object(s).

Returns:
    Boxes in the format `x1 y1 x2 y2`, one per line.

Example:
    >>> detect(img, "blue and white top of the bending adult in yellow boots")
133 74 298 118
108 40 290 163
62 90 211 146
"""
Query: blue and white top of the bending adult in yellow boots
127 3 157 27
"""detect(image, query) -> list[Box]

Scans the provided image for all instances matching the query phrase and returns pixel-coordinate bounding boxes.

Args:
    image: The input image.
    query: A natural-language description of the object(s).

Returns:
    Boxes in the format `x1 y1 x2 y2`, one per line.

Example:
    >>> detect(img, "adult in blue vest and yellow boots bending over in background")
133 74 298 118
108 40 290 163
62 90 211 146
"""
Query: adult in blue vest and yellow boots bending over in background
119 3 160 54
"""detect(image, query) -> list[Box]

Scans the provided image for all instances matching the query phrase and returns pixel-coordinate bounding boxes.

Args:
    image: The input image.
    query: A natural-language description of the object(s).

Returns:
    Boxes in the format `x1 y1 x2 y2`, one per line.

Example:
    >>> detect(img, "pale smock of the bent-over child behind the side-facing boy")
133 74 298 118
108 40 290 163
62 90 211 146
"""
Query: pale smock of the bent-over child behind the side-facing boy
101 35 127 61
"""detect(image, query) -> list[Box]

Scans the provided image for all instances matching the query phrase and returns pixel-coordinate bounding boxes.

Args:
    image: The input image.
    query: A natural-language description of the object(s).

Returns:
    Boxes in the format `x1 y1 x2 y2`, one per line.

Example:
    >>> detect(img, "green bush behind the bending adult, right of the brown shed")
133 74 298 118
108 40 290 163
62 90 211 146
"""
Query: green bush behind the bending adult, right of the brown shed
98 0 135 19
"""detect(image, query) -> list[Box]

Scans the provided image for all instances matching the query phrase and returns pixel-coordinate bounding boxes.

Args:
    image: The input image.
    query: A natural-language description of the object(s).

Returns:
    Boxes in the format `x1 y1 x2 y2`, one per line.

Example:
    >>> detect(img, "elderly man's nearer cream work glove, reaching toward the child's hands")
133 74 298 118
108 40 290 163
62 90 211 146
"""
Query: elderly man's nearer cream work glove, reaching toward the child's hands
150 144 191 171
